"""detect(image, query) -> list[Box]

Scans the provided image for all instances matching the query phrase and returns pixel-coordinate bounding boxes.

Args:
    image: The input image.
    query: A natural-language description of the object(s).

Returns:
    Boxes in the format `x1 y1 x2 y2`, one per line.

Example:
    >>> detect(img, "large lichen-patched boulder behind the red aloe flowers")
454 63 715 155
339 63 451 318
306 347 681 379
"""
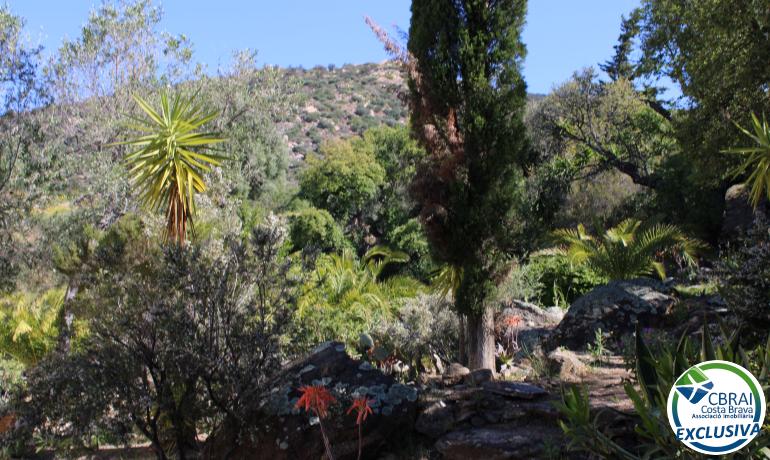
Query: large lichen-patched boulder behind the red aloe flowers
205 342 418 460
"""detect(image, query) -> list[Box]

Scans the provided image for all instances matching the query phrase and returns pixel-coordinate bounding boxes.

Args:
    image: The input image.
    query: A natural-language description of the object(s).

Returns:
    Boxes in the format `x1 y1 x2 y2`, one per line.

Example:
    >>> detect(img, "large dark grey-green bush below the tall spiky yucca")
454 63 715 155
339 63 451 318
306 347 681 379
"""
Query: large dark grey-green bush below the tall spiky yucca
13 220 298 458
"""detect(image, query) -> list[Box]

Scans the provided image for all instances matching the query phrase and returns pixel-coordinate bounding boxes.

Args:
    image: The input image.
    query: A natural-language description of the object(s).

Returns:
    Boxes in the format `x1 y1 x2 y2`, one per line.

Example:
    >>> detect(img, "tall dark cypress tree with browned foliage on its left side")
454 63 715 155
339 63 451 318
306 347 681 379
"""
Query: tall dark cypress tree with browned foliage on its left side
407 0 530 369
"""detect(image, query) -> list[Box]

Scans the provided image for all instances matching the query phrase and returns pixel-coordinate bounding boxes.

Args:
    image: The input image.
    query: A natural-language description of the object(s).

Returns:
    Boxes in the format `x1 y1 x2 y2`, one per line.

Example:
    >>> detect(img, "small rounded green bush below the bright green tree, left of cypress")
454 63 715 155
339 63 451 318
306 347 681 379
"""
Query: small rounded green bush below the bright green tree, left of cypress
289 207 349 252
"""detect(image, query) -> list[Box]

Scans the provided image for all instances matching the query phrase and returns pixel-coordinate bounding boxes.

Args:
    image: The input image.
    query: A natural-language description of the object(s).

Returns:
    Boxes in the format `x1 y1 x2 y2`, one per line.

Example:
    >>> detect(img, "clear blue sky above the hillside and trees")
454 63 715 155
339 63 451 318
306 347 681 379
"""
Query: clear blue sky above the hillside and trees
10 0 639 93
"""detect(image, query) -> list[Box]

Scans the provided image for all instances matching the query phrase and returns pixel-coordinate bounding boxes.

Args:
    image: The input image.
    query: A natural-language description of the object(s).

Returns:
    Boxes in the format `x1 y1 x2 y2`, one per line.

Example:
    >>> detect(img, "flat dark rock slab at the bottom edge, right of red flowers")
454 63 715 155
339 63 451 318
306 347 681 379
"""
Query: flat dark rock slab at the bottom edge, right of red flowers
435 423 562 460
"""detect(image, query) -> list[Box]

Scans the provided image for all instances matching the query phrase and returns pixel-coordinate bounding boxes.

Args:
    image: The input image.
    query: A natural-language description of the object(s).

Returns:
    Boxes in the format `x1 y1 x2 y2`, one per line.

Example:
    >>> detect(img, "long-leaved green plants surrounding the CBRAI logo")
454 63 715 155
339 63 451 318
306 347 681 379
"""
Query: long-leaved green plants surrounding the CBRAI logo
556 321 770 460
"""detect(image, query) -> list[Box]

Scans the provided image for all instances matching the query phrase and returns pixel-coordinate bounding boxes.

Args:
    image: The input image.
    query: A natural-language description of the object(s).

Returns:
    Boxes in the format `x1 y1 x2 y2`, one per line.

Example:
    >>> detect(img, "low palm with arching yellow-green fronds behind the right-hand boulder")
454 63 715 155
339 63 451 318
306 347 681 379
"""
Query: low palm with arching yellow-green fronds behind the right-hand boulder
543 219 703 280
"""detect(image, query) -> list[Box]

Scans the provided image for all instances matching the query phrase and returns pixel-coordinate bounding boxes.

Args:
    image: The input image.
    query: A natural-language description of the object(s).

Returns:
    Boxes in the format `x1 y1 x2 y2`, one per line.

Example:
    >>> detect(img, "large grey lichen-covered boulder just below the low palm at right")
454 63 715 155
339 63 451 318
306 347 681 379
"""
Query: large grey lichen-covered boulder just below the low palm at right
546 278 676 350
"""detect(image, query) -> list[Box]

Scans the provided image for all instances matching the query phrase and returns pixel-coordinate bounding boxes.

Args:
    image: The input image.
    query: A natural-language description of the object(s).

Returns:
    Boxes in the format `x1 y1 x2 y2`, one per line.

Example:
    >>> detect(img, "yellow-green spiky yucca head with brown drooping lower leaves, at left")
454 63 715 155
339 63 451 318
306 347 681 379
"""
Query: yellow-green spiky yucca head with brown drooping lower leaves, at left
113 91 226 245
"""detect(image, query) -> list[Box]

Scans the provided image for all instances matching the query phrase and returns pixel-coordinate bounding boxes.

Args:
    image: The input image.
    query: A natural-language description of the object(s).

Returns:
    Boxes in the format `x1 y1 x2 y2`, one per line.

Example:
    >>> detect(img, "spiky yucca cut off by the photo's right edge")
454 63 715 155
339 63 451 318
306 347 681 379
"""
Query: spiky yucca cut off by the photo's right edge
724 113 770 209
